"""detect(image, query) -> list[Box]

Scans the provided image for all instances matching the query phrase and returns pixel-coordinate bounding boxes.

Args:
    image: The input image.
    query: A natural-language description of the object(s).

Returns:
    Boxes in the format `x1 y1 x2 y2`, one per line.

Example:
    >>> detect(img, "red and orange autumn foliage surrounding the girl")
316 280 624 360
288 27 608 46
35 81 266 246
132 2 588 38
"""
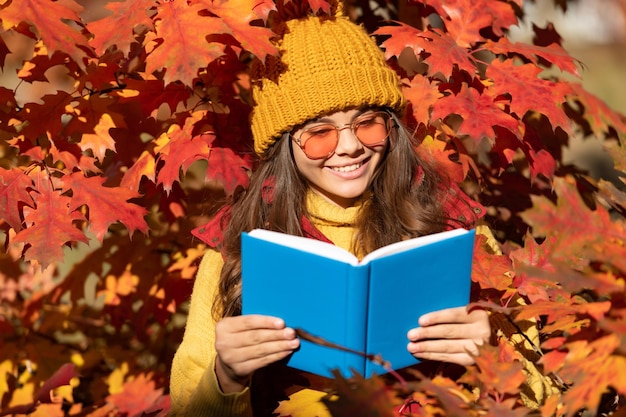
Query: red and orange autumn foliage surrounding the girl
0 0 626 416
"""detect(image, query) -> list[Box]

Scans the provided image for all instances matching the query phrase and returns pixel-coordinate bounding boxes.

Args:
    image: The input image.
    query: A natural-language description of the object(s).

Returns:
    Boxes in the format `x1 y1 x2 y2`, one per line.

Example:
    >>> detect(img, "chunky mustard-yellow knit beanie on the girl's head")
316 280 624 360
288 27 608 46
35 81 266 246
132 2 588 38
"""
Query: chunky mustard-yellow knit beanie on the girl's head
251 16 406 155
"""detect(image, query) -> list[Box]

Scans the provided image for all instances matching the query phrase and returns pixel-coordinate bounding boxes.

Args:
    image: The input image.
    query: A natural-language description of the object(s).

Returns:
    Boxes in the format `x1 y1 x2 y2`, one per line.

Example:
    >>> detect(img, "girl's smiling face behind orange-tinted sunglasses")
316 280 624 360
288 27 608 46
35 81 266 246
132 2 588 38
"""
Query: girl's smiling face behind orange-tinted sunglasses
292 110 391 208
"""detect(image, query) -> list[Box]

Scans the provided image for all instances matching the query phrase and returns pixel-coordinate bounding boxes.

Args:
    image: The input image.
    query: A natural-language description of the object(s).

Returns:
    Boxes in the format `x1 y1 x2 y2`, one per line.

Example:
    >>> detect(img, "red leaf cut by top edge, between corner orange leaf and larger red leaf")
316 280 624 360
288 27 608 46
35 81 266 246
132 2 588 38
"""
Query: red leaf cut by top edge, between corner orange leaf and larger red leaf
86 0 154 55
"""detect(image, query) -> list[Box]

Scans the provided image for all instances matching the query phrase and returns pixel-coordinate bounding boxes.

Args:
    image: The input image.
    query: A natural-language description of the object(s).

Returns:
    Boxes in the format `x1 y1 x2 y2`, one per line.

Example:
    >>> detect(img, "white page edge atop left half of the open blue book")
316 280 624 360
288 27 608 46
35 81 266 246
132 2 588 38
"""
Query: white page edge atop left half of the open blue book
248 229 359 265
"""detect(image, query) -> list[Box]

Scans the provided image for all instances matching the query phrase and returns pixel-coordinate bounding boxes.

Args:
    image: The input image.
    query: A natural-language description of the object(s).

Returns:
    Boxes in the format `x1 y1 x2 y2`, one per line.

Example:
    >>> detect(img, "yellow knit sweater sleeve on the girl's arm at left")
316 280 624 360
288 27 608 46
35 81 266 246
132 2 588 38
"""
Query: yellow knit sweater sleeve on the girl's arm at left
170 250 252 417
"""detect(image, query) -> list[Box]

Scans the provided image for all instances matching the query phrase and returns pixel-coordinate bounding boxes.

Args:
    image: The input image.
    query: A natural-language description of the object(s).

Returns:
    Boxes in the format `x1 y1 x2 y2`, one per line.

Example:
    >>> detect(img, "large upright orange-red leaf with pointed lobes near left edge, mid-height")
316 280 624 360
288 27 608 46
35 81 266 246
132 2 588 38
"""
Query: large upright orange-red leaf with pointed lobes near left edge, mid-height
13 174 88 268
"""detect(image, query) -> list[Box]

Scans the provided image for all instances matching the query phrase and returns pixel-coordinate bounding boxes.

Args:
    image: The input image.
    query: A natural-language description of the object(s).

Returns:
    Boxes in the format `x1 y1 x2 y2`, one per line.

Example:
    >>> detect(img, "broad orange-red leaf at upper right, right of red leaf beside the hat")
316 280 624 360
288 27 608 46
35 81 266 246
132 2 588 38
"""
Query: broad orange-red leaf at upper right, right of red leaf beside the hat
487 60 573 133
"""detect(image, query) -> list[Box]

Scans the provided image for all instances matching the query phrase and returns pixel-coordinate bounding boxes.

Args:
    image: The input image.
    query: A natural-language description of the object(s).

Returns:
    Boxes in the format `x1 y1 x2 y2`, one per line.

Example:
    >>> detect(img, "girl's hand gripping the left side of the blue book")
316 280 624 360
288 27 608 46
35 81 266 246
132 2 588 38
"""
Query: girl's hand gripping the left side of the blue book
215 314 300 393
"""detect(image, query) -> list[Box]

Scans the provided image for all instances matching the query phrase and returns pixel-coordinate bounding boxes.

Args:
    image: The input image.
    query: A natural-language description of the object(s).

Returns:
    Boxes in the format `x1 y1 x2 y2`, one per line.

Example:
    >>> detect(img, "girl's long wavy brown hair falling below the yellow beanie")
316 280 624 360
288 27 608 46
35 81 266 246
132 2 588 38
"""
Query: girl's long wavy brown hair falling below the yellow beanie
213 109 458 318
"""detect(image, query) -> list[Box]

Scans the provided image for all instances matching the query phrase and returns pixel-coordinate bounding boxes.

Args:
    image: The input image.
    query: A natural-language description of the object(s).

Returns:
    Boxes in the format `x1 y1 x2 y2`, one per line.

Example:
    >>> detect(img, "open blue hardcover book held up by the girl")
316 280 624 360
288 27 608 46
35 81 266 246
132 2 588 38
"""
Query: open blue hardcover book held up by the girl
241 229 475 377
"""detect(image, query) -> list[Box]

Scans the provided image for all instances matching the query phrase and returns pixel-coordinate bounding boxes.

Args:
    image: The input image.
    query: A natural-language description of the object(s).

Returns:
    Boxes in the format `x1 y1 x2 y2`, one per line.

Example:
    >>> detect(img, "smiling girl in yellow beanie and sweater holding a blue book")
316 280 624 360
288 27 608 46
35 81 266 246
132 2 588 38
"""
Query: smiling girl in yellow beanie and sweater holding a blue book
171 6 552 417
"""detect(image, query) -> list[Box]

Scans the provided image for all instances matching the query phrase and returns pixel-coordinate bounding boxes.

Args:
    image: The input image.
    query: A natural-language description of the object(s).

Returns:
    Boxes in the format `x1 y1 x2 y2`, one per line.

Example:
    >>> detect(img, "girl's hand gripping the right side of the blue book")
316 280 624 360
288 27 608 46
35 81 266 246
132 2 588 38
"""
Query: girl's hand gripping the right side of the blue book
407 307 491 365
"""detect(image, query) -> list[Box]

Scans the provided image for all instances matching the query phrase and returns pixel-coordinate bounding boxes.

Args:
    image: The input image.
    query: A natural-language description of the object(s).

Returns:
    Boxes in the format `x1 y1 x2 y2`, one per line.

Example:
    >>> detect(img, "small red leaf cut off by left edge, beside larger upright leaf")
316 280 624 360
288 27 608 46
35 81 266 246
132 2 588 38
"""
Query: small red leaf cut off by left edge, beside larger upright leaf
0 167 33 231
